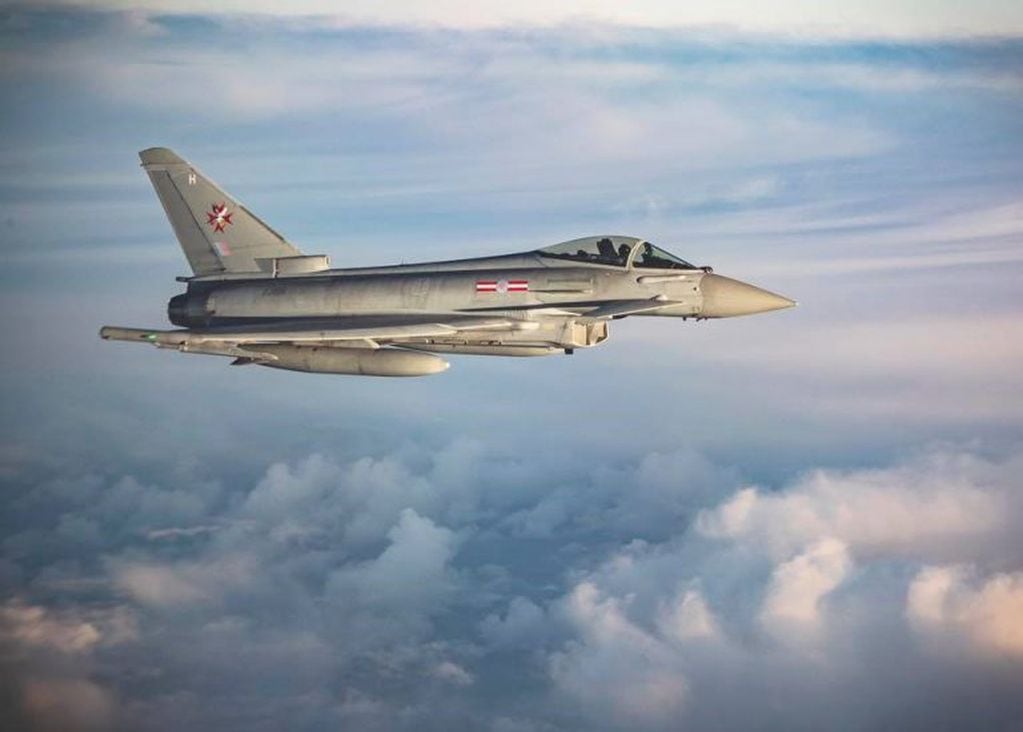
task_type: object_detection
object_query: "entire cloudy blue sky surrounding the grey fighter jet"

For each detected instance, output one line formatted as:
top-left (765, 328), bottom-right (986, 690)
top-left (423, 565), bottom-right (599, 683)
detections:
top-left (0, 0), bottom-right (1023, 732)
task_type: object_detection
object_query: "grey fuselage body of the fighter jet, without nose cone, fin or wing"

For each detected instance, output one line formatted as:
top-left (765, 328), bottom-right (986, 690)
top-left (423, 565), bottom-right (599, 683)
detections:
top-left (169, 251), bottom-right (716, 355)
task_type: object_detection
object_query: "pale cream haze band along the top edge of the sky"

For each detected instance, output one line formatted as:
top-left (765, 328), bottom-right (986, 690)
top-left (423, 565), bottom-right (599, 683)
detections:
top-left (49, 0), bottom-right (1023, 38)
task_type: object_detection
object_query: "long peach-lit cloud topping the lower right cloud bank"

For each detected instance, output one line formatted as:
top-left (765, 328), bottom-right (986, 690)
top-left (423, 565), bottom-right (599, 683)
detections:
top-left (697, 451), bottom-right (1023, 559)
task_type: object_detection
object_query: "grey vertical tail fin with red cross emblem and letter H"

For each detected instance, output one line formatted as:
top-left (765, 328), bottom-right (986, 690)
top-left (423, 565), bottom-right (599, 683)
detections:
top-left (138, 147), bottom-right (302, 275)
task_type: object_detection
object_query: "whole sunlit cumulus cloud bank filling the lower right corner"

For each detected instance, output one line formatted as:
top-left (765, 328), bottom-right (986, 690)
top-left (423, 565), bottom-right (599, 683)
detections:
top-left (531, 451), bottom-right (1023, 729)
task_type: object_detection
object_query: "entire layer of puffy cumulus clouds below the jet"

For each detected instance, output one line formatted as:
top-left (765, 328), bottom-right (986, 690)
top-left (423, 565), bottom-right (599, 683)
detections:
top-left (0, 440), bottom-right (1023, 730)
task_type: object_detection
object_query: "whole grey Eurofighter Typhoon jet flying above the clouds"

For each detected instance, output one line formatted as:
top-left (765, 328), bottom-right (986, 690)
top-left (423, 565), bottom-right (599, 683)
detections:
top-left (99, 147), bottom-right (795, 376)
